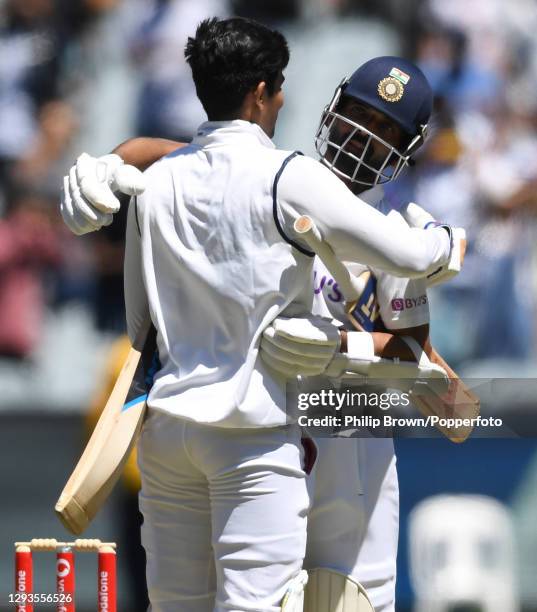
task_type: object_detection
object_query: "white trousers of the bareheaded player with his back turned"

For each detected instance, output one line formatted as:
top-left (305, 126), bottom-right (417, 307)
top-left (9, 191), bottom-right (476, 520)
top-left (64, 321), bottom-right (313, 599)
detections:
top-left (138, 410), bottom-right (309, 612)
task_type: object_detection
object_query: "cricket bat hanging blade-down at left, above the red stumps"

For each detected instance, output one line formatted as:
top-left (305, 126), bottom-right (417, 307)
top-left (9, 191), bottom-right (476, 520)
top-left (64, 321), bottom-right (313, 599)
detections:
top-left (55, 314), bottom-right (156, 535)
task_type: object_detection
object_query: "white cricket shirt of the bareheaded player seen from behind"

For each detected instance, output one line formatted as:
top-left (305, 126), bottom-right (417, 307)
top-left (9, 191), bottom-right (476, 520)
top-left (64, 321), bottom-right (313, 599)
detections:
top-left (125, 120), bottom-right (449, 427)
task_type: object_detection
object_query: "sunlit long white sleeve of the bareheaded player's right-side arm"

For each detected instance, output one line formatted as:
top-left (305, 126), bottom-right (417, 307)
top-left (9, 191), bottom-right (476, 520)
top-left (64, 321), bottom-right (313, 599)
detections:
top-left (277, 156), bottom-right (450, 278)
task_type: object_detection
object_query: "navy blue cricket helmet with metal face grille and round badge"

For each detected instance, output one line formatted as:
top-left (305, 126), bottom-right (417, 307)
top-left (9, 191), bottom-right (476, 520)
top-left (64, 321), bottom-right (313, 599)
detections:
top-left (315, 56), bottom-right (433, 189)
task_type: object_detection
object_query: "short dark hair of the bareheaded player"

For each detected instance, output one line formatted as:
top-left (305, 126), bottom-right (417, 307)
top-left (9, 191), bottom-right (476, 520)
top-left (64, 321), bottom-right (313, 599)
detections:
top-left (185, 17), bottom-right (289, 121)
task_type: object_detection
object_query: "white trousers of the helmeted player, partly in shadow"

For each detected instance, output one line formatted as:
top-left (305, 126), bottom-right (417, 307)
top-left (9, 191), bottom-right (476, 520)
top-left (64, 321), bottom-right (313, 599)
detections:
top-left (304, 438), bottom-right (399, 612)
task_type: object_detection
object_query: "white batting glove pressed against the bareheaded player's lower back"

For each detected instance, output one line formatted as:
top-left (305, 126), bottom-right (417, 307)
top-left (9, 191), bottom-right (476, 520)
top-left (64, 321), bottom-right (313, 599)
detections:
top-left (259, 316), bottom-right (340, 378)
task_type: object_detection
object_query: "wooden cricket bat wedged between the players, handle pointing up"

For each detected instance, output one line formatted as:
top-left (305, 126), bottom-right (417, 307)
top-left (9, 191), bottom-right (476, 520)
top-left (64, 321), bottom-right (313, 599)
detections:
top-left (294, 215), bottom-right (480, 443)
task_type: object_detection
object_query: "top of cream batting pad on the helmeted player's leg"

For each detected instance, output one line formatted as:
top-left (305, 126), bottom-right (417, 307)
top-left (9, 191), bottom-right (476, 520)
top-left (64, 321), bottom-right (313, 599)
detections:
top-left (304, 568), bottom-right (375, 612)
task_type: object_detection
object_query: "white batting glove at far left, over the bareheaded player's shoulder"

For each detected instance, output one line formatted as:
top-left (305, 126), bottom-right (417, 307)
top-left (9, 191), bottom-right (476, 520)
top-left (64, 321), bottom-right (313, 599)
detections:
top-left (60, 153), bottom-right (145, 236)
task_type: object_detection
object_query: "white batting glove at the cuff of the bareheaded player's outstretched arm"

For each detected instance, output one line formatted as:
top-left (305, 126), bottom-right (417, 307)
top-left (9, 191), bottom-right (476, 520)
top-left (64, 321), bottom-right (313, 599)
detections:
top-left (401, 202), bottom-right (466, 287)
